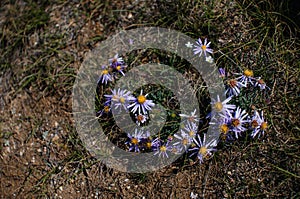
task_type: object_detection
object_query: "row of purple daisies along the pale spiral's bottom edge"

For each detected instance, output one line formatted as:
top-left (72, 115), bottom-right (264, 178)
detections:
top-left (126, 110), bottom-right (218, 163)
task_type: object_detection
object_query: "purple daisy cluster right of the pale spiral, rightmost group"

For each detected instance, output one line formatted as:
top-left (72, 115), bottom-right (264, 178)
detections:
top-left (212, 64), bottom-right (270, 141)
